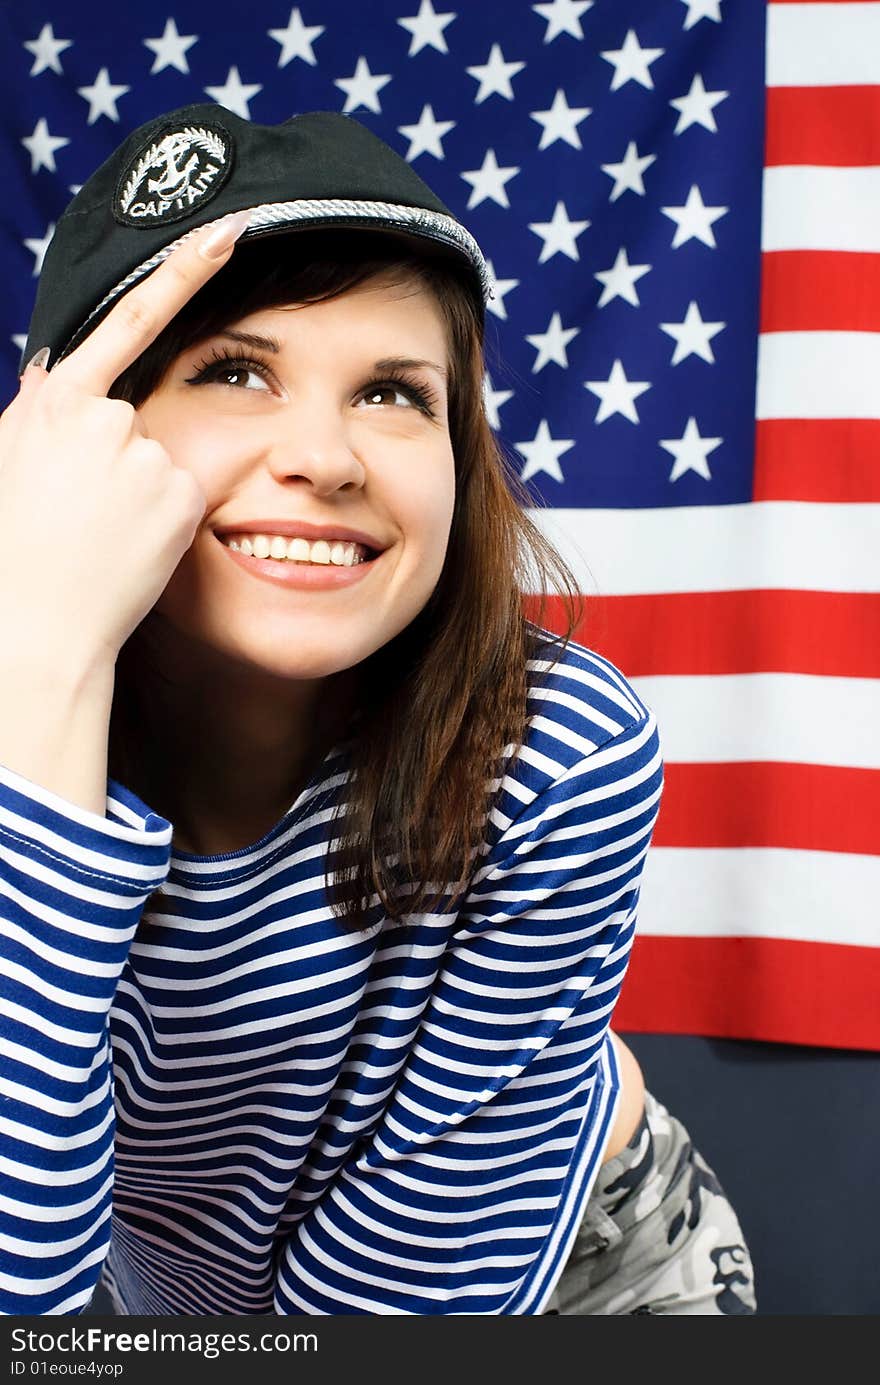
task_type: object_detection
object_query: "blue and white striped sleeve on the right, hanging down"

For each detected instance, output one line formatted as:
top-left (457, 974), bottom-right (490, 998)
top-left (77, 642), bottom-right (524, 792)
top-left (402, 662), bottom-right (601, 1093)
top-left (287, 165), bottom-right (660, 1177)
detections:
top-left (276, 709), bottom-right (662, 1314)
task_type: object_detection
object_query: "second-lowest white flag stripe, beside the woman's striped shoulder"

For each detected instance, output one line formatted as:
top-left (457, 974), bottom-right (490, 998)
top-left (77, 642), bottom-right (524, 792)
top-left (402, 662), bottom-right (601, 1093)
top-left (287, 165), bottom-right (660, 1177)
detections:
top-left (631, 673), bottom-right (880, 769)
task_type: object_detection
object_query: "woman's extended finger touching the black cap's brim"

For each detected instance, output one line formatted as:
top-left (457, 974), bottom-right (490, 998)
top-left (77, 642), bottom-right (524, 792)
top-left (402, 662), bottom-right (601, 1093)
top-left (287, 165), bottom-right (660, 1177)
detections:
top-left (53, 212), bottom-right (249, 395)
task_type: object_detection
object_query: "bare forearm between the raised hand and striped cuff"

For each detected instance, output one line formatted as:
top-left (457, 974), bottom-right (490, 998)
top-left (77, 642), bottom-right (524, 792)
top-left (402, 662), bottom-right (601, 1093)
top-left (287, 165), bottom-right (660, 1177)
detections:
top-left (0, 642), bottom-right (115, 817)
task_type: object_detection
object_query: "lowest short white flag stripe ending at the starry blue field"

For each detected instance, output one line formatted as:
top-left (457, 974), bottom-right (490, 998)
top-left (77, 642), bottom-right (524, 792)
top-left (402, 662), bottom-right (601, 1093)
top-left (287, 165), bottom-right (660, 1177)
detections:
top-left (755, 332), bottom-right (880, 418)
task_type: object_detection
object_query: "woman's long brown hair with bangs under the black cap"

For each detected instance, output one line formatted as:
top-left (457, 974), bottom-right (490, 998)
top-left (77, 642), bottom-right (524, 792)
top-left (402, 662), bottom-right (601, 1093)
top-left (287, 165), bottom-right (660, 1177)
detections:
top-left (109, 231), bottom-right (583, 927)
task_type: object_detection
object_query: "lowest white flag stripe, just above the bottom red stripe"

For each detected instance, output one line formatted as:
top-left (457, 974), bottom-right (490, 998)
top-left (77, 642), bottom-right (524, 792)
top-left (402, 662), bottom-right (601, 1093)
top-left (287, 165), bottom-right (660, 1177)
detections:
top-left (636, 846), bottom-right (880, 947)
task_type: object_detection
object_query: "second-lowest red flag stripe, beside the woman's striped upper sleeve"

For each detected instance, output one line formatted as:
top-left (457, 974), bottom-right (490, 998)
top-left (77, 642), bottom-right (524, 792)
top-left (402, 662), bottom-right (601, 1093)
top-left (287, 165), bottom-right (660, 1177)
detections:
top-left (653, 760), bottom-right (880, 853)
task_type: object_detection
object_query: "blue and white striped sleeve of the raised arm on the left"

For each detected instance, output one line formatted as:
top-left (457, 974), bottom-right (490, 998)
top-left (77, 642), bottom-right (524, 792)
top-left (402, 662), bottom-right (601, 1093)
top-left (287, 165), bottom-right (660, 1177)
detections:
top-left (0, 767), bottom-right (172, 1316)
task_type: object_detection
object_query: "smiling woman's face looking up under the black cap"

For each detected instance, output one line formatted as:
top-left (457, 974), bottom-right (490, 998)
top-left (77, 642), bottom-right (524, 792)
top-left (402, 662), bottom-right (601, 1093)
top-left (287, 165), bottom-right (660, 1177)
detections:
top-left (139, 274), bottom-right (455, 679)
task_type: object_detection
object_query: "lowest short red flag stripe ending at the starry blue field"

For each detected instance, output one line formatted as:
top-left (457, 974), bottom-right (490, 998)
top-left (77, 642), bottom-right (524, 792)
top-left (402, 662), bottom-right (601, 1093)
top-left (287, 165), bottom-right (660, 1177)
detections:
top-left (753, 418), bottom-right (880, 504)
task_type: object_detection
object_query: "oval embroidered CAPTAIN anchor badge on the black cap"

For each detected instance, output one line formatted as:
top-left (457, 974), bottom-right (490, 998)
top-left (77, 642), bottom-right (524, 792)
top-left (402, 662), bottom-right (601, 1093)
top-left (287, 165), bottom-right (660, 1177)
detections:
top-left (114, 125), bottom-right (233, 226)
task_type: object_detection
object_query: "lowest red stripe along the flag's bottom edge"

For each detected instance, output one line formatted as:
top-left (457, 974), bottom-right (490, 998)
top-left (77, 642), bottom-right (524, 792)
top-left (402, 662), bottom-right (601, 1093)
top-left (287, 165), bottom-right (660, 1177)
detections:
top-left (614, 933), bottom-right (880, 1050)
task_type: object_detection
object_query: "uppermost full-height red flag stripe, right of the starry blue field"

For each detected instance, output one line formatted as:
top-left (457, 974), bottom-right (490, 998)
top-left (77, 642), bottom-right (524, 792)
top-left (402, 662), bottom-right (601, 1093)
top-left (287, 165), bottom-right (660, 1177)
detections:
top-left (764, 86), bottom-right (880, 168)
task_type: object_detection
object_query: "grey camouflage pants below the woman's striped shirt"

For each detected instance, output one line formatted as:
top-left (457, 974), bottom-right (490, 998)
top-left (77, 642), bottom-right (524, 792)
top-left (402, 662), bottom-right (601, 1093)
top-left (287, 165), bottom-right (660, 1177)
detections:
top-left (545, 1093), bottom-right (755, 1316)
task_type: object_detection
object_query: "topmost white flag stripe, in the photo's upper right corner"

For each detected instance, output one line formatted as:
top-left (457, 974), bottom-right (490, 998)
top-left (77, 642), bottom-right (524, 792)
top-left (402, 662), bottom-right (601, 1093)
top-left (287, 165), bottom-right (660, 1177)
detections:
top-left (766, 4), bottom-right (880, 86)
